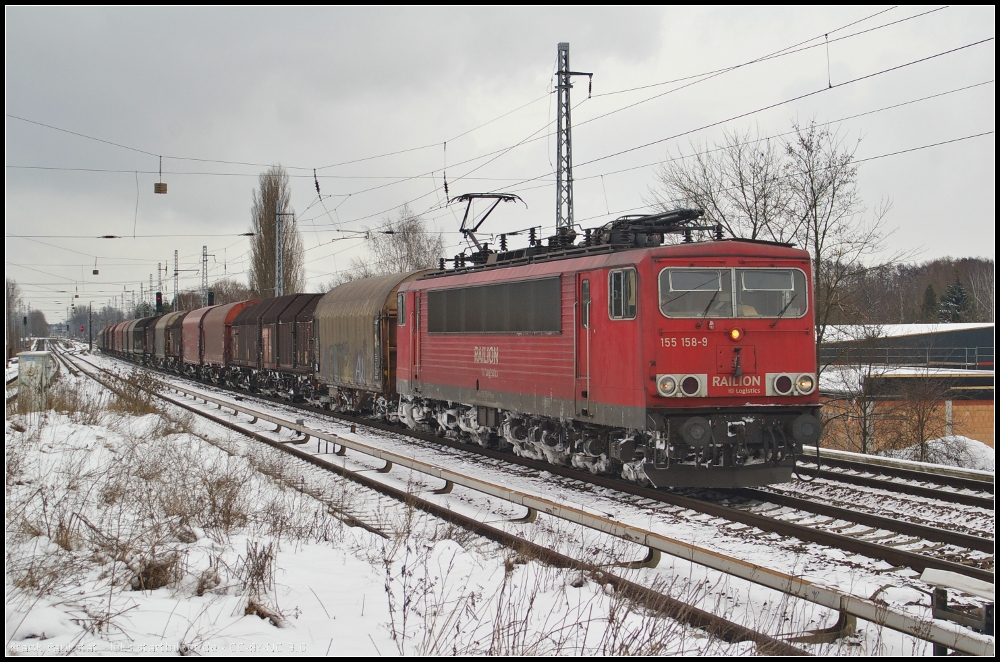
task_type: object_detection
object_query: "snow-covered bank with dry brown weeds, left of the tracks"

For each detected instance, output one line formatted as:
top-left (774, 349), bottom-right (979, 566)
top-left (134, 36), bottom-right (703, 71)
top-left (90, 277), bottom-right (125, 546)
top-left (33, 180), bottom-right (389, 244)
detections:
top-left (5, 376), bottom-right (755, 656)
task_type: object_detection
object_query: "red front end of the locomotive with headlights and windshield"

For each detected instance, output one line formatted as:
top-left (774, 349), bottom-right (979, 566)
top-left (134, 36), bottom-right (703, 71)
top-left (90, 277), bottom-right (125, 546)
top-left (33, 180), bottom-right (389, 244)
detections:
top-left (611, 241), bottom-right (821, 487)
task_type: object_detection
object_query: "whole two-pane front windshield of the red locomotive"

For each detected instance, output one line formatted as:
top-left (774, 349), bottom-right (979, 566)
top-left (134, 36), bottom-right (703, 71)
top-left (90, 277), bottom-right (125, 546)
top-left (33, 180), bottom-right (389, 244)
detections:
top-left (660, 269), bottom-right (808, 318)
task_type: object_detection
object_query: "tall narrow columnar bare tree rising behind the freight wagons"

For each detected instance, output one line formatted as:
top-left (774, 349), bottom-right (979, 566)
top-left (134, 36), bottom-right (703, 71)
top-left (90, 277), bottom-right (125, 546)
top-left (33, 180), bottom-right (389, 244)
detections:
top-left (250, 165), bottom-right (305, 299)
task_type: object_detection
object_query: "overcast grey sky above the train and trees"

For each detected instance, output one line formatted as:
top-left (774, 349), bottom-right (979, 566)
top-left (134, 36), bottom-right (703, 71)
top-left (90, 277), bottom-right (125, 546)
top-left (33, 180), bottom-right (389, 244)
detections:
top-left (4, 5), bottom-right (995, 321)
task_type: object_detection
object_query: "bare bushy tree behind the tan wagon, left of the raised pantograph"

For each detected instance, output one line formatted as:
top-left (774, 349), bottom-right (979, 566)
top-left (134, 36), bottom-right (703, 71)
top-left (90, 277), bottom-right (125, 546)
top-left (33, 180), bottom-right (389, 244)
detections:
top-left (323, 205), bottom-right (444, 291)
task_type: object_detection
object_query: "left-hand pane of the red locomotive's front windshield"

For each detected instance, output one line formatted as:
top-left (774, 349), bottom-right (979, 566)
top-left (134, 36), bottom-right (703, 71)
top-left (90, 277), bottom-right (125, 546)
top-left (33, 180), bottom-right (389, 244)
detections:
top-left (660, 269), bottom-right (733, 318)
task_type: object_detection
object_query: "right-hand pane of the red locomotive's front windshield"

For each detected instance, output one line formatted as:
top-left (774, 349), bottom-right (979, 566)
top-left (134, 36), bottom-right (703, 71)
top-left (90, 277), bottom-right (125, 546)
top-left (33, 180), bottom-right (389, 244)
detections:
top-left (736, 269), bottom-right (809, 317)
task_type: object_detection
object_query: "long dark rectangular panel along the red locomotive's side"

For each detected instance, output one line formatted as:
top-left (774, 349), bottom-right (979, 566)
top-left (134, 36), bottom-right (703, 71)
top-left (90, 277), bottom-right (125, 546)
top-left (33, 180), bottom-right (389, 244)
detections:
top-left (427, 277), bottom-right (562, 333)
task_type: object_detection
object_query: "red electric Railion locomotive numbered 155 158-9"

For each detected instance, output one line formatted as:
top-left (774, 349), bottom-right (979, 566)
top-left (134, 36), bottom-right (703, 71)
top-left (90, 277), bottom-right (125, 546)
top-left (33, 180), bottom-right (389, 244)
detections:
top-left (396, 210), bottom-right (820, 487)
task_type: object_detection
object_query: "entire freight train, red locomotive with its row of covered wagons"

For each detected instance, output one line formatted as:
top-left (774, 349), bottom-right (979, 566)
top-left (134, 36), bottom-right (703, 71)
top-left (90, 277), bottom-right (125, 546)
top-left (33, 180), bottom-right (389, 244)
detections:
top-left (100, 210), bottom-right (820, 488)
